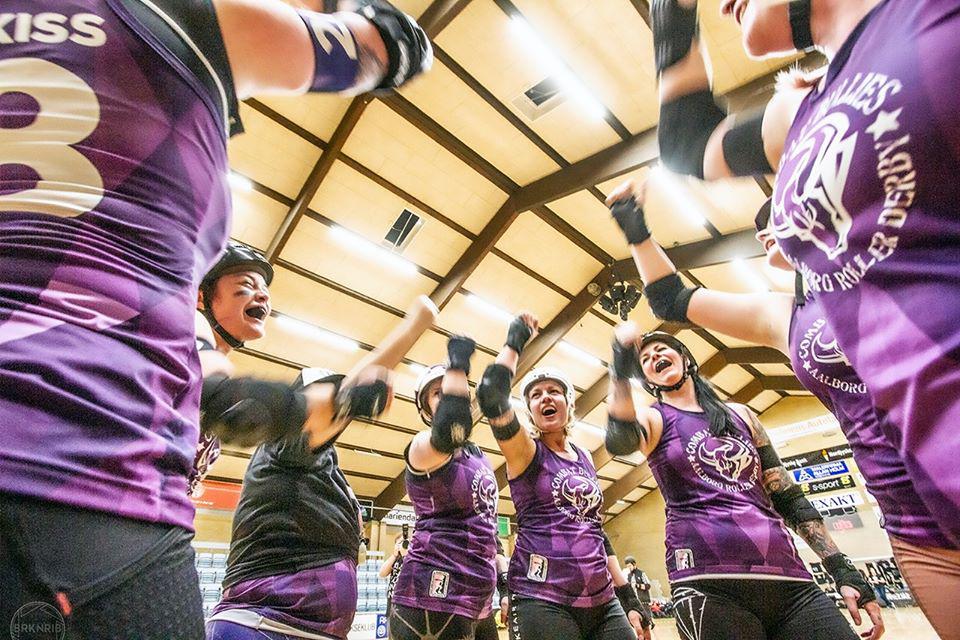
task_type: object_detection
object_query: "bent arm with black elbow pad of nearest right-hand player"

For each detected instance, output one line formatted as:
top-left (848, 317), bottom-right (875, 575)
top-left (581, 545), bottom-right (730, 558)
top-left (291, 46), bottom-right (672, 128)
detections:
top-left (650, 0), bottom-right (807, 180)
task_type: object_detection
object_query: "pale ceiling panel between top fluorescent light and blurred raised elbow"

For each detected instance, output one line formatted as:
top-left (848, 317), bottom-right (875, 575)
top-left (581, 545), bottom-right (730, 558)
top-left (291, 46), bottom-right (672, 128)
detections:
top-left (515, 0), bottom-right (658, 133)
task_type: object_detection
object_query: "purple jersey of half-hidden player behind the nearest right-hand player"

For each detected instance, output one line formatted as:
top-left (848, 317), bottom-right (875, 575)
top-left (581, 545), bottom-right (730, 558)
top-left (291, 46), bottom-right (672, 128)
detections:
top-left (790, 297), bottom-right (956, 548)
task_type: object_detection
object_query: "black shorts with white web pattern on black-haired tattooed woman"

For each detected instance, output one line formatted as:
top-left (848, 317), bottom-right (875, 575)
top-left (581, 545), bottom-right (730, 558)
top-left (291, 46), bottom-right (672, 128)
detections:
top-left (672, 578), bottom-right (858, 640)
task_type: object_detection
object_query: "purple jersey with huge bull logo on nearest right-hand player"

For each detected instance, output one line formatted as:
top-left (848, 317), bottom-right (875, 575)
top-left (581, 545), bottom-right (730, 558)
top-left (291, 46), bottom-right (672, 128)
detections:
top-left (771, 0), bottom-right (960, 541)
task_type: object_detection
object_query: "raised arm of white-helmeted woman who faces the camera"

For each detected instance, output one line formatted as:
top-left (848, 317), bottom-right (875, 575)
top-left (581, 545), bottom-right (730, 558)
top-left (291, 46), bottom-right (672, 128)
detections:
top-left (477, 313), bottom-right (539, 478)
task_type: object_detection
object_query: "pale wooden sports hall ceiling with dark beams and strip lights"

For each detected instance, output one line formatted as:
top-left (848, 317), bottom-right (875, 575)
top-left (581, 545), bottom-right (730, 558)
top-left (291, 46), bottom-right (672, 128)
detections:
top-left (211, 0), bottom-right (803, 516)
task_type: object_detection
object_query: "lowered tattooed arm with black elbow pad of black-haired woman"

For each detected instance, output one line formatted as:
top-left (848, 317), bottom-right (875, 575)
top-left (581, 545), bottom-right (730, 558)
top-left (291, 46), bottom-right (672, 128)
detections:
top-left (731, 405), bottom-right (883, 640)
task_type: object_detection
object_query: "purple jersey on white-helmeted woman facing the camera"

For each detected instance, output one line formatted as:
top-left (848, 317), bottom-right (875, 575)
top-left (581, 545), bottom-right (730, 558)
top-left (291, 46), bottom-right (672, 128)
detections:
top-left (508, 440), bottom-right (614, 607)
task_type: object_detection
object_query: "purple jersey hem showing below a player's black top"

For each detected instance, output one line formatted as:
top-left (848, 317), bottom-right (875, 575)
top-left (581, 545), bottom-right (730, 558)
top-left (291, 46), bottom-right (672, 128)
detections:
top-left (213, 558), bottom-right (357, 638)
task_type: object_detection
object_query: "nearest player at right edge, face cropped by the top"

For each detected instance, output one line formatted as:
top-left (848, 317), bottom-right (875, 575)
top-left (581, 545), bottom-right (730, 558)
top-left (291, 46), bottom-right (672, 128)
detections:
top-left (651, 0), bottom-right (960, 580)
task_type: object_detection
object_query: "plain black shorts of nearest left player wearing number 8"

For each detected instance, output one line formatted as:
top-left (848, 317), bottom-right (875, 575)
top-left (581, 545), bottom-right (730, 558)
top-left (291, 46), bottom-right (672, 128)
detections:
top-left (0, 494), bottom-right (204, 640)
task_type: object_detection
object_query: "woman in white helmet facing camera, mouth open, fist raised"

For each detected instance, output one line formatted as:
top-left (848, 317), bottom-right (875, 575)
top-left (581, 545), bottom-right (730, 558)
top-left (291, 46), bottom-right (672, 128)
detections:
top-left (477, 320), bottom-right (642, 640)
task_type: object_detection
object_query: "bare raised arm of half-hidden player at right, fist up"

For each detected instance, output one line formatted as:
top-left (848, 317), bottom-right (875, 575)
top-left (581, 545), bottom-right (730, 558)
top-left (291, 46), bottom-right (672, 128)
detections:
top-left (607, 181), bottom-right (793, 353)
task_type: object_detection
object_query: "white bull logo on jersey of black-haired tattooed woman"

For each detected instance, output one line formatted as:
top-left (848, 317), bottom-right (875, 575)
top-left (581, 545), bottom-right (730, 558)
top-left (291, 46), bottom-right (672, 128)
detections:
top-left (686, 429), bottom-right (760, 493)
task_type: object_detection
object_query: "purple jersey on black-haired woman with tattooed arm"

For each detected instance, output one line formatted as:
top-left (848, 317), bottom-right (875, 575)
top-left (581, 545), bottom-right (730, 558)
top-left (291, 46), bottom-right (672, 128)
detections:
top-left (648, 403), bottom-right (812, 583)
